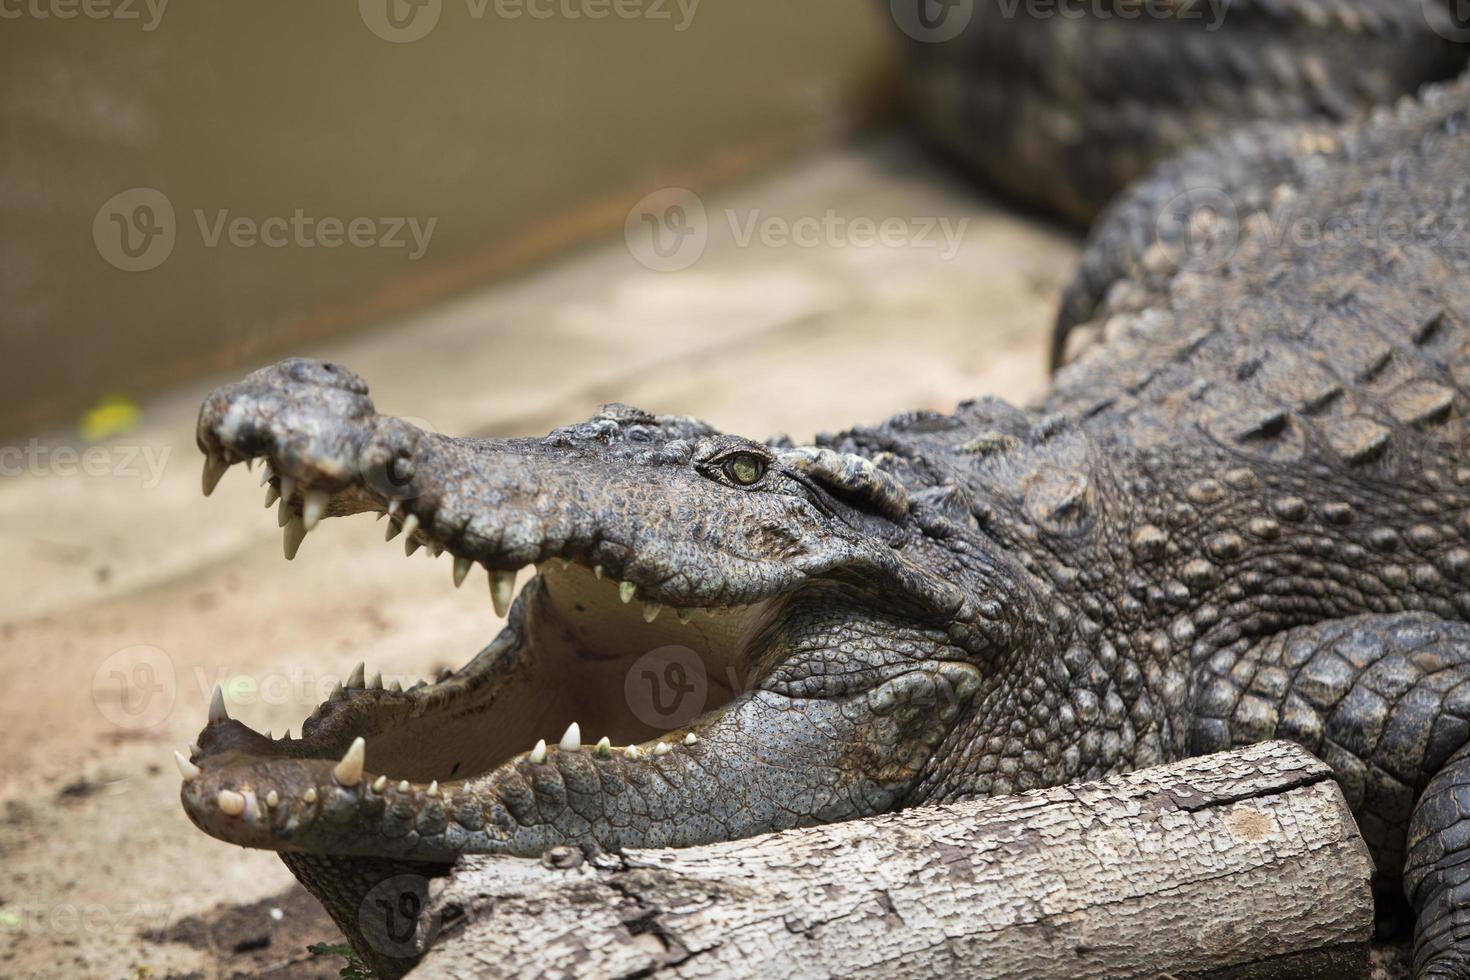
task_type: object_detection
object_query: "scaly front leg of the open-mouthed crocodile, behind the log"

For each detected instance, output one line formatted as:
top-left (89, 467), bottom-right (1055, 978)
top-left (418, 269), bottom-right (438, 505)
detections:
top-left (1191, 613), bottom-right (1470, 977)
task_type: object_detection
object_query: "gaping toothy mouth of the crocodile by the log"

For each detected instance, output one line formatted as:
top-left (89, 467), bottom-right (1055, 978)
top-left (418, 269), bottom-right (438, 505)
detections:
top-left (178, 455), bottom-right (772, 860)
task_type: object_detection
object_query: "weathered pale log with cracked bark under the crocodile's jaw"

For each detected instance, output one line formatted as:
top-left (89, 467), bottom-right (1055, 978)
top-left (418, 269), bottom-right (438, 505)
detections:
top-left (415, 742), bottom-right (1373, 979)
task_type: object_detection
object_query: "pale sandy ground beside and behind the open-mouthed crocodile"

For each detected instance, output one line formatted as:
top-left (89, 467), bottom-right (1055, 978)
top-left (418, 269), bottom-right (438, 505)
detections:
top-left (0, 143), bottom-right (1076, 977)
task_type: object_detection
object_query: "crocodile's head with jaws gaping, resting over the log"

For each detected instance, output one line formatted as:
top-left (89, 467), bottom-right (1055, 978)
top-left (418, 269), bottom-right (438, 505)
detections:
top-left (181, 360), bottom-right (1017, 963)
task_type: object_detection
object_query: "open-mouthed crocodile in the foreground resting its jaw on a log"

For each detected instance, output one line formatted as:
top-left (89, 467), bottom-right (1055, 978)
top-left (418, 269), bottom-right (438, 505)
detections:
top-left (186, 3), bottom-right (1470, 977)
